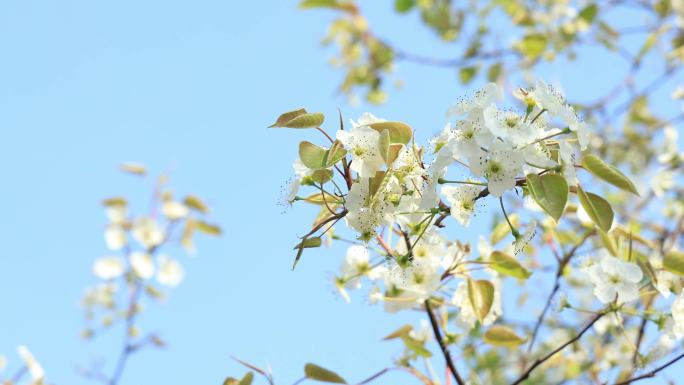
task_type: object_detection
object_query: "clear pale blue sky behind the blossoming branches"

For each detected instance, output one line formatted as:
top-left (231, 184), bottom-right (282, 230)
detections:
top-left (0, 0), bottom-right (681, 384)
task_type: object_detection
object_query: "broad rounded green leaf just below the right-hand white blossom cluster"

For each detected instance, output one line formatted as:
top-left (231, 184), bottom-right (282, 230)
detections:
top-left (527, 174), bottom-right (568, 222)
